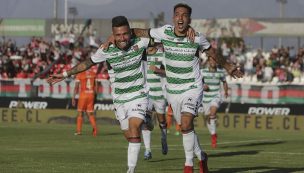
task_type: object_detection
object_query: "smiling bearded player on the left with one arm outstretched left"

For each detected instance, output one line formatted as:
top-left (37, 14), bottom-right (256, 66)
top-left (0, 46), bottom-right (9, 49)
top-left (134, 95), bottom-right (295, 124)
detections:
top-left (47, 16), bottom-right (154, 173)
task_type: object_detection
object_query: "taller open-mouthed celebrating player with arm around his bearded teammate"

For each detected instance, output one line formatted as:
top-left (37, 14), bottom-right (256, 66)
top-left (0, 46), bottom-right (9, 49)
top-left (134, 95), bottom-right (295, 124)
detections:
top-left (132, 3), bottom-right (243, 173)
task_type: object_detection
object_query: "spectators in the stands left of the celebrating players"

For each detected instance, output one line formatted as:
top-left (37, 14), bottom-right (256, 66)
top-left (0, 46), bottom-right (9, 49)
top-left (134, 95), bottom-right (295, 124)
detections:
top-left (0, 32), bottom-right (108, 79)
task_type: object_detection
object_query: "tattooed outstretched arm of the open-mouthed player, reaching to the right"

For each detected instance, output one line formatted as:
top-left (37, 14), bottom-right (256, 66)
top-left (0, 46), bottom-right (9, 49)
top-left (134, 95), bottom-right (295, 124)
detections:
top-left (206, 48), bottom-right (244, 78)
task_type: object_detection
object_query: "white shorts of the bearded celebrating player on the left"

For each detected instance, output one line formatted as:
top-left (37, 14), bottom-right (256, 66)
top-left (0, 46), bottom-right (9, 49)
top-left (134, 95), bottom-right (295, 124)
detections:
top-left (114, 97), bottom-right (148, 130)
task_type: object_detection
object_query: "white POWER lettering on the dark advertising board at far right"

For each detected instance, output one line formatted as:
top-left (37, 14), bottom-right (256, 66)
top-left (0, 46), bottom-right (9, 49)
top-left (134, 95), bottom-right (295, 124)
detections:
top-left (248, 107), bottom-right (290, 115)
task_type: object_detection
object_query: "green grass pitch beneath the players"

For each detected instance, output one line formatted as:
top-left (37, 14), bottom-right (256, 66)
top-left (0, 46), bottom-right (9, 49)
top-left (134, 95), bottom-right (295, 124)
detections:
top-left (0, 123), bottom-right (304, 173)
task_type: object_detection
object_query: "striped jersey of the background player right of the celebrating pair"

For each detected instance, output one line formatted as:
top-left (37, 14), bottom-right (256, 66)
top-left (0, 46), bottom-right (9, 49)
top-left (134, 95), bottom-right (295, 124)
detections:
top-left (201, 68), bottom-right (226, 103)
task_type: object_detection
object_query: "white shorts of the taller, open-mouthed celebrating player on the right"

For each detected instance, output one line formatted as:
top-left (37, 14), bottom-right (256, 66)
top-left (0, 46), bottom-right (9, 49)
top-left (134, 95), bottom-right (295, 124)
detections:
top-left (167, 88), bottom-right (203, 125)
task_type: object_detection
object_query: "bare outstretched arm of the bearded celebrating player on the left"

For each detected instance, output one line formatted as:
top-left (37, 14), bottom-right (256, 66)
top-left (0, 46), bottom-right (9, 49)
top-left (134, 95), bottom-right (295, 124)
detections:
top-left (47, 58), bottom-right (94, 85)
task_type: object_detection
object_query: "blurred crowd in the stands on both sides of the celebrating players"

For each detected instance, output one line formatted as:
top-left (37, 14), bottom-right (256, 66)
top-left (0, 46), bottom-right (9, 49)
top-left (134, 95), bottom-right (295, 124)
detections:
top-left (0, 32), bottom-right (304, 83)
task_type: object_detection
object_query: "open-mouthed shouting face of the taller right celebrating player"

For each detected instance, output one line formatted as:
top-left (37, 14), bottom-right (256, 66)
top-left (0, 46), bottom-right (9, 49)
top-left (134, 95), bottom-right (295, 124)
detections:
top-left (173, 7), bottom-right (191, 36)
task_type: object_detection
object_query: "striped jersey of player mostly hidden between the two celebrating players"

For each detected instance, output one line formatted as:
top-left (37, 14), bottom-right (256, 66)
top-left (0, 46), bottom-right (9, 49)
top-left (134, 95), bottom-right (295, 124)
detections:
top-left (147, 49), bottom-right (165, 100)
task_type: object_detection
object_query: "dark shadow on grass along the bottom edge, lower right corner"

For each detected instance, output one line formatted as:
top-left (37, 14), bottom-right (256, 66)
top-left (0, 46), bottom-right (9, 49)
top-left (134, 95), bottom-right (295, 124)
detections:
top-left (209, 166), bottom-right (304, 173)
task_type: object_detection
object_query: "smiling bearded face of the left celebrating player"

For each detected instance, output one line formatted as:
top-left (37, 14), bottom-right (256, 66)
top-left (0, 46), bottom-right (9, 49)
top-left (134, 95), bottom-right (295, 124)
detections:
top-left (112, 25), bottom-right (131, 50)
